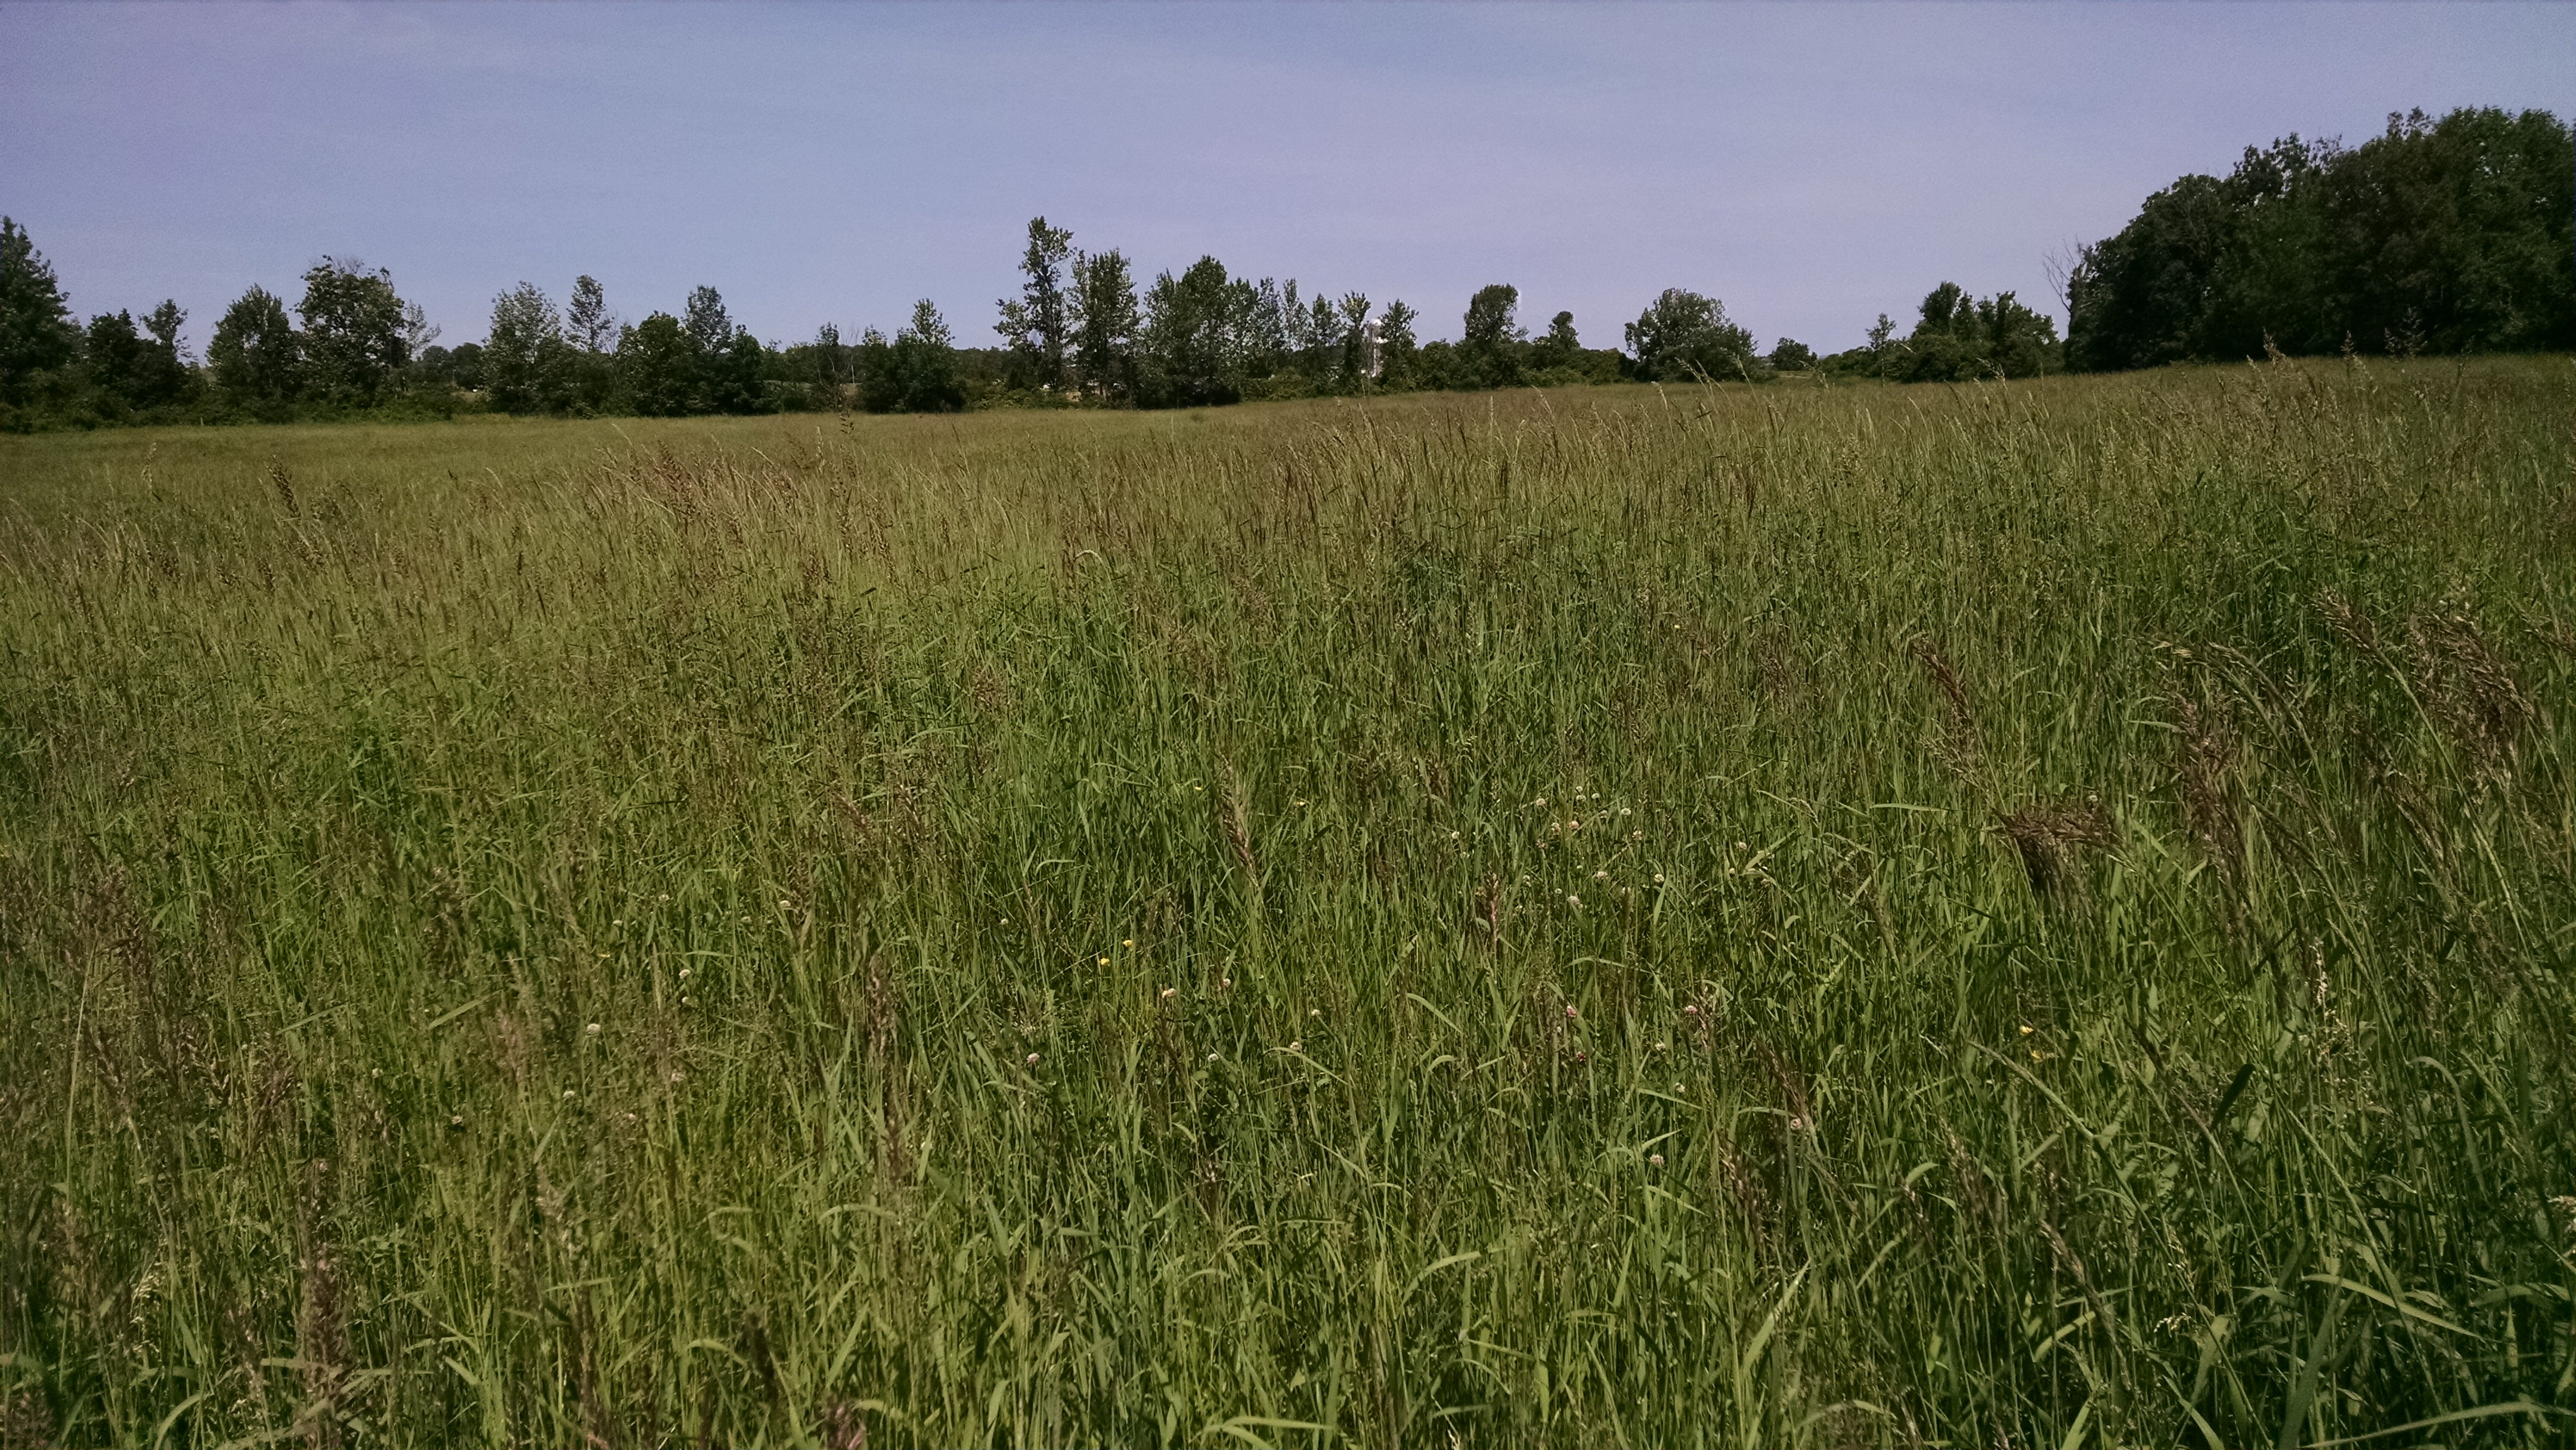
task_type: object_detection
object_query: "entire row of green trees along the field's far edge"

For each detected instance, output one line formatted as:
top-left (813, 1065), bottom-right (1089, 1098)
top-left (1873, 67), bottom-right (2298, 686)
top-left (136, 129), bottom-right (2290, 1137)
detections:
top-left (0, 111), bottom-right (2576, 430)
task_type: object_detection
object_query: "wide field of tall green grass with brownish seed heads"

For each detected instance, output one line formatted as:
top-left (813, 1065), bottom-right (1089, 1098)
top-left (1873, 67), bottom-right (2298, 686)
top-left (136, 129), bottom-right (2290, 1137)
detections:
top-left (0, 358), bottom-right (2576, 1450)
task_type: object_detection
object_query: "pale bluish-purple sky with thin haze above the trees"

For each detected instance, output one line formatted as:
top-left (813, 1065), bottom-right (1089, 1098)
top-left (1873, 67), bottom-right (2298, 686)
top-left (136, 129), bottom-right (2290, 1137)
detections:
top-left (0, 2), bottom-right (2576, 350)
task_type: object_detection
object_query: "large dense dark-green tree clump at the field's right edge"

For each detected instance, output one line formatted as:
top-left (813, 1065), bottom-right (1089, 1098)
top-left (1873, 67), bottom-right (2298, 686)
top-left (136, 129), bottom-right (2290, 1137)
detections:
top-left (2069, 108), bottom-right (2576, 371)
